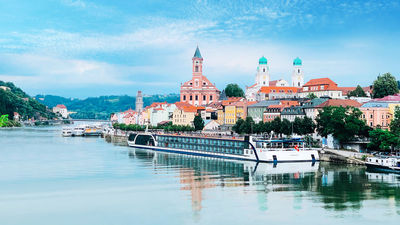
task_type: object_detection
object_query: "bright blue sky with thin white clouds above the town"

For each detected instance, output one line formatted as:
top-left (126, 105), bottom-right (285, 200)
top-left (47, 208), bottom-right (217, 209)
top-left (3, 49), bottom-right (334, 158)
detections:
top-left (0, 0), bottom-right (400, 98)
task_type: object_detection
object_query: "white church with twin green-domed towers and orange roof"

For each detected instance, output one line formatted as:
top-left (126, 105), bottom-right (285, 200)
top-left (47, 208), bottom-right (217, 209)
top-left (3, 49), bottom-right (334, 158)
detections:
top-left (246, 56), bottom-right (304, 101)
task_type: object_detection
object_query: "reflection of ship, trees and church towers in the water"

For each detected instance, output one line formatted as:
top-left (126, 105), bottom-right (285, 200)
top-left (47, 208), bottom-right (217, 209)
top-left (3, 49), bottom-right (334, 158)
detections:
top-left (129, 150), bottom-right (400, 214)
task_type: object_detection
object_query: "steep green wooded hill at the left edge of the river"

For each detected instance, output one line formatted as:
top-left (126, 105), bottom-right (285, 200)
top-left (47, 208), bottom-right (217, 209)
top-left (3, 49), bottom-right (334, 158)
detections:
top-left (0, 81), bottom-right (55, 119)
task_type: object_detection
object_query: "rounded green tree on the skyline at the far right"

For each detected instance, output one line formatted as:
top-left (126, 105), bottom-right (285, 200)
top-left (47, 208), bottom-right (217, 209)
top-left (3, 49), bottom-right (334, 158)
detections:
top-left (372, 73), bottom-right (399, 98)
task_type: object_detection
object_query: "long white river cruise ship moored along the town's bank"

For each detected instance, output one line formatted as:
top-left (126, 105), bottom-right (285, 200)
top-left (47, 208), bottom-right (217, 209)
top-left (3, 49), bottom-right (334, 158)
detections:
top-left (128, 132), bottom-right (319, 163)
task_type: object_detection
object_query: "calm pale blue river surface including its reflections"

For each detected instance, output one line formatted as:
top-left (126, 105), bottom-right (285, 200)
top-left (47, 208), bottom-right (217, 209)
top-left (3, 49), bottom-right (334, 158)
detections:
top-left (0, 125), bottom-right (400, 225)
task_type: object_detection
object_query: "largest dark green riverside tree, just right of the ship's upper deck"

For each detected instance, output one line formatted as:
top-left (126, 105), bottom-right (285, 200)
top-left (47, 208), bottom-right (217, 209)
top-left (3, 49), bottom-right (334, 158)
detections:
top-left (316, 106), bottom-right (366, 146)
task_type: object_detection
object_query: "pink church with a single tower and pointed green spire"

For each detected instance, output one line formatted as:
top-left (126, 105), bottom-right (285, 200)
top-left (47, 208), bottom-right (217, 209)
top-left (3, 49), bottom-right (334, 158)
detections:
top-left (181, 47), bottom-right (220, 106)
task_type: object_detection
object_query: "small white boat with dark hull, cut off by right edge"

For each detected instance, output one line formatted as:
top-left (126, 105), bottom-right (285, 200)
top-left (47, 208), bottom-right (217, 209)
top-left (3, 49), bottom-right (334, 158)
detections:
top-left (365, 156), bottom-right (400, 173)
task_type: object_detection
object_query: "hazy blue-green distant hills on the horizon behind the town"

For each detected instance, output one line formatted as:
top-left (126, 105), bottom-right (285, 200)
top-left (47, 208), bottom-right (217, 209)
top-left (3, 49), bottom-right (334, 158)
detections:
top-left (35, 94), bottom-right (179, 119)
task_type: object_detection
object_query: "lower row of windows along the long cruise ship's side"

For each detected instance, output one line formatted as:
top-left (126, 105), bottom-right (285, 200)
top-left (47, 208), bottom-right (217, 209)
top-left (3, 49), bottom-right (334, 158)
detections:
top-left (158, 142), bottom-right (243, 155)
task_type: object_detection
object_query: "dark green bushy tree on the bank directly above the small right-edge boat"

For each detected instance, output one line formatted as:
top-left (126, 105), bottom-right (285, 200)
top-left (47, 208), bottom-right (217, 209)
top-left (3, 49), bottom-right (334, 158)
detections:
top-left (367, 129), bottom-right (399, 151)
